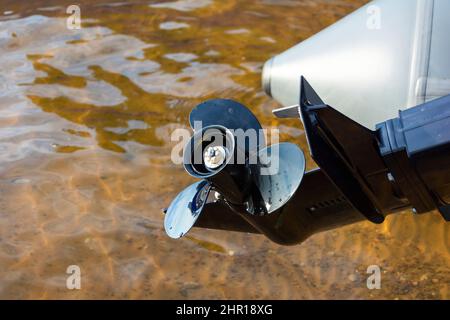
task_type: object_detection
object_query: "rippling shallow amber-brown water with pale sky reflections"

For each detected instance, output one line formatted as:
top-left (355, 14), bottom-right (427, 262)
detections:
top-left (0, 0), bottom-right (450, 299)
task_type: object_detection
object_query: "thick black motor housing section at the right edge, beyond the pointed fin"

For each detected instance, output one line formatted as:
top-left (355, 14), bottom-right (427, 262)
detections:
top-left (377, 96), bottom-right (450, 221)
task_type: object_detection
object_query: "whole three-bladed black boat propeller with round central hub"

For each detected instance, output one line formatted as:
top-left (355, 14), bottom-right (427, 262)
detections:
top-left (164, 99), bottom-right (305, 238)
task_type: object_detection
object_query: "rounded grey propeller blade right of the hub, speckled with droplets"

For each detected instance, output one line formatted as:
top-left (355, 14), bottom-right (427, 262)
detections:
top-left (254, 143), bottom-right (306, 214)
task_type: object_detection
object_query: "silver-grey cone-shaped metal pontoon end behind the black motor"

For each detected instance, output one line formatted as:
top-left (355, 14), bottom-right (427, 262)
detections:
top-left (263, 0), bottom-right (450, 129)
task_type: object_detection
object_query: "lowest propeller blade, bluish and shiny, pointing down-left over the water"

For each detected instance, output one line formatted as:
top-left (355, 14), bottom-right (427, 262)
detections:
top-left (164, 180), bottom-right (211, 239)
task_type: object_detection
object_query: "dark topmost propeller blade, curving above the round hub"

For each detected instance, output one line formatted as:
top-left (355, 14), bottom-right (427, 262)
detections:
top-left (189, 99), bottom-right (265, 151)
